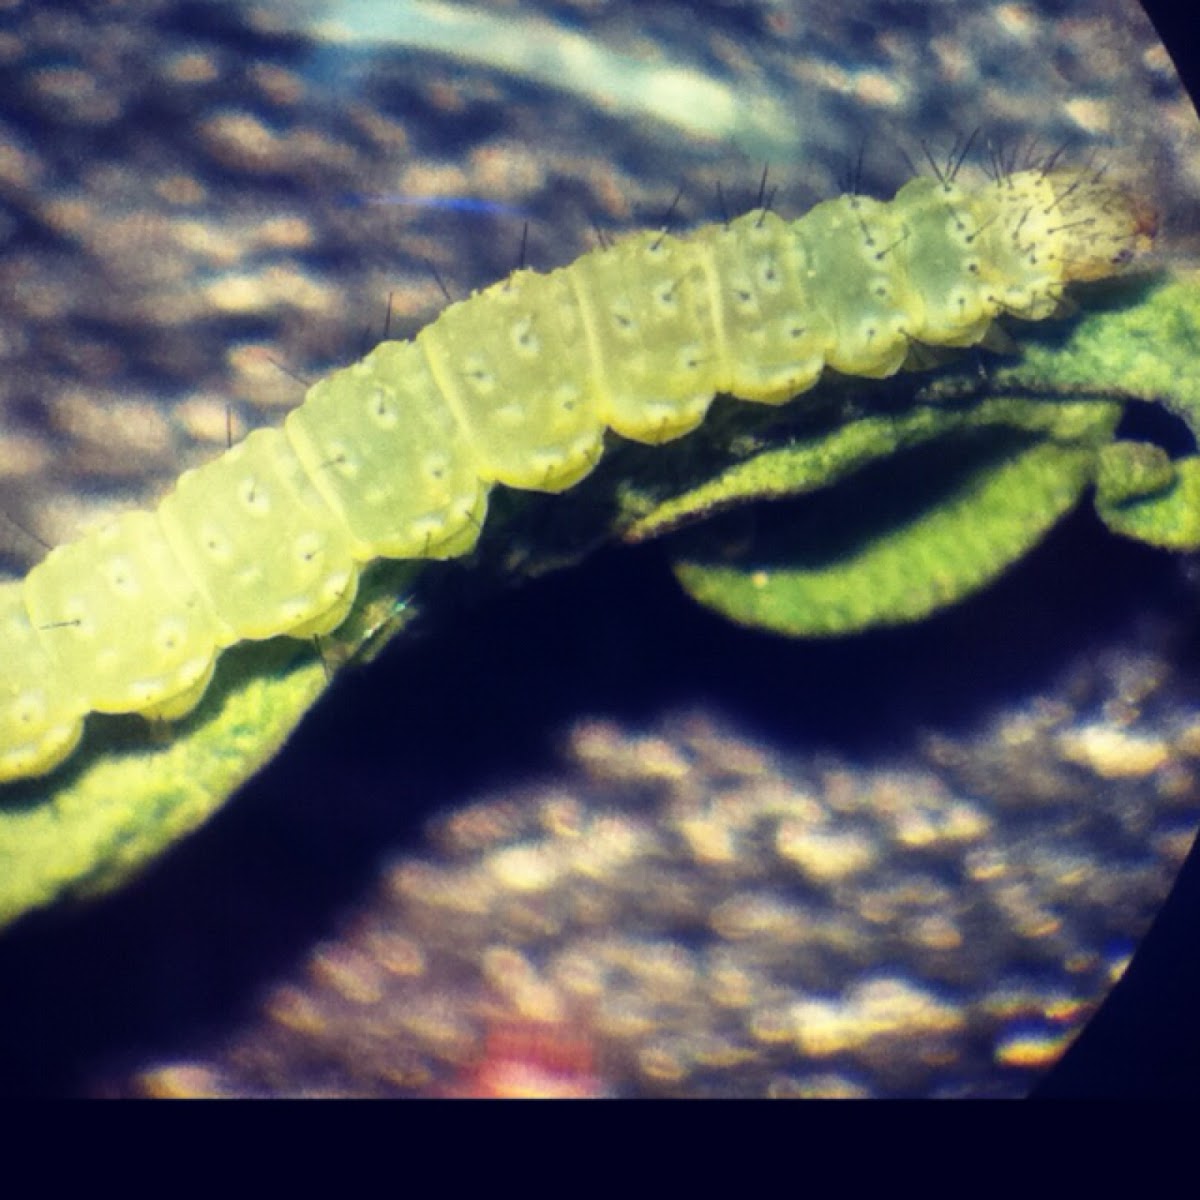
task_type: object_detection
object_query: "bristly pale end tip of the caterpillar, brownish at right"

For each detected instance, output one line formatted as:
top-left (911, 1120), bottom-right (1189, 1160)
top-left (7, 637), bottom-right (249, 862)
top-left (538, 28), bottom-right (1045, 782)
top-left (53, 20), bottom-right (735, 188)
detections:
top-left (1054, 175), bottom-right (1158, 283)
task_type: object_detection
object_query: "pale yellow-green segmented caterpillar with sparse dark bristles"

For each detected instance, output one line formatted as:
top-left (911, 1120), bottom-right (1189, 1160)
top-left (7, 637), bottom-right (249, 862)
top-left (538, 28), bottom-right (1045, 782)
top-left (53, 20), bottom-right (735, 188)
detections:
top-left (0, 163), bottom-right (1154, 782)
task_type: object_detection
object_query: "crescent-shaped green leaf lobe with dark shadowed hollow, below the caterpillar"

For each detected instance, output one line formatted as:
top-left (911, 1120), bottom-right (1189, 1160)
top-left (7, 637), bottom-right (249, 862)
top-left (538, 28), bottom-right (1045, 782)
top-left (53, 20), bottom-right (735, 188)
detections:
top-left (674, 427), bottom-right (1113, 637)
